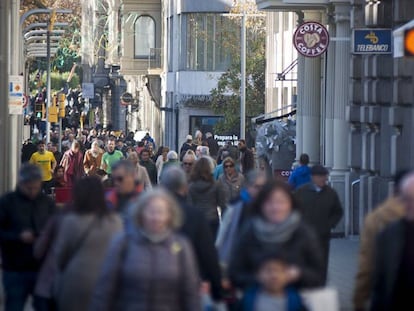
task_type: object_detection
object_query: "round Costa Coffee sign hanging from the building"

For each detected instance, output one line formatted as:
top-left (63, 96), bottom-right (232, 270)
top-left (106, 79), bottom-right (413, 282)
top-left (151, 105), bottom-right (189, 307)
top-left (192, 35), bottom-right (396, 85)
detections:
top-left (293, 22), bottom-right (329, 57)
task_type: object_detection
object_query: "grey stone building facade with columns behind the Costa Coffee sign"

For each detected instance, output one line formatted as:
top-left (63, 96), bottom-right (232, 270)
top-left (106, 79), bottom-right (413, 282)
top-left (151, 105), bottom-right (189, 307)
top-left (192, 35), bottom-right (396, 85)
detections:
top-left (256, 0), bottom-right (414, 235)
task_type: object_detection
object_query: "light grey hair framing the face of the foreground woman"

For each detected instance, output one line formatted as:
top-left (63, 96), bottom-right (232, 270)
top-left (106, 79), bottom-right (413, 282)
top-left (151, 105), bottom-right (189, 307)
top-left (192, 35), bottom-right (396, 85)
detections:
top-left (128, 188), bottom-right (182, 230)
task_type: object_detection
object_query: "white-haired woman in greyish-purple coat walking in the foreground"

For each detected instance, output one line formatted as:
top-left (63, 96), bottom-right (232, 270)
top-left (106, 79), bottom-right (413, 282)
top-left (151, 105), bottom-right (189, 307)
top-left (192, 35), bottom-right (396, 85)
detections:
top-left (90, 189), bottom-right (201, 311)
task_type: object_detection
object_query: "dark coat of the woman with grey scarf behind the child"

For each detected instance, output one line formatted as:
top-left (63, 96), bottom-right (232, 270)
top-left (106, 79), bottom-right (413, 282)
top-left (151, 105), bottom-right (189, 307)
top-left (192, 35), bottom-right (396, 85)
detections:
top-left (229, 219), bottom-right (323, 288)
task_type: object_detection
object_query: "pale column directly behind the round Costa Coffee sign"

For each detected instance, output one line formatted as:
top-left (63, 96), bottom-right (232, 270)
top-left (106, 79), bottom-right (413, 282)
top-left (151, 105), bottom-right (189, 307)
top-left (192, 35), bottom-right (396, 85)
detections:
top-left (298, 11), bottom-right (322, 163)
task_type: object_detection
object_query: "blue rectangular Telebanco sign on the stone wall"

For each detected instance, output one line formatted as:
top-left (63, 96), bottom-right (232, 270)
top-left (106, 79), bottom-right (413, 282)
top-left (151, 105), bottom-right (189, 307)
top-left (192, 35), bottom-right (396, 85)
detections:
top-left (352, 28), bottom-right (392, 54)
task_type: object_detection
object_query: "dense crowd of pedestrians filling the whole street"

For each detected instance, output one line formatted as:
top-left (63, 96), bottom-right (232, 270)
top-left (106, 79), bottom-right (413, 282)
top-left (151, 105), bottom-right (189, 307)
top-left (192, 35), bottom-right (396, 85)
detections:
top-left (0, 130), bottom-right (414, 311)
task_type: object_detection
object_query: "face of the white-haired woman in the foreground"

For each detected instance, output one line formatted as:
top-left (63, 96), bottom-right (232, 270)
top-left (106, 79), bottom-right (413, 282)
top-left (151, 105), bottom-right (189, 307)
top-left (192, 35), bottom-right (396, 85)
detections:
top-left (142, 198), bottom-right (171, 234)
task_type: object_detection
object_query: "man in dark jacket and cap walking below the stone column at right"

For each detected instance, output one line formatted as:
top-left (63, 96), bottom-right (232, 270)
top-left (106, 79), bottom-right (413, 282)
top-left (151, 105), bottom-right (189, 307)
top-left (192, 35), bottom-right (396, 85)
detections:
top-left (295, 165), bottom-right (343, 282)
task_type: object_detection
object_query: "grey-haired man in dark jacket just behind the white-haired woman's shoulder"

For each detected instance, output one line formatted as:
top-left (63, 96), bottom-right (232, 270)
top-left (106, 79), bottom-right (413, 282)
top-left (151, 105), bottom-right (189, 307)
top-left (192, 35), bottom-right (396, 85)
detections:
top-left (161, 166), bottom-right (223, 308)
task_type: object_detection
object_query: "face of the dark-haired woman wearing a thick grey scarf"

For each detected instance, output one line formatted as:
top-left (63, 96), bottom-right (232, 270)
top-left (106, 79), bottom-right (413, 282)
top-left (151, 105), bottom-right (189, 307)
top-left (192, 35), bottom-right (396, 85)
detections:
top-left (262, 190), bottom-right (292, 223)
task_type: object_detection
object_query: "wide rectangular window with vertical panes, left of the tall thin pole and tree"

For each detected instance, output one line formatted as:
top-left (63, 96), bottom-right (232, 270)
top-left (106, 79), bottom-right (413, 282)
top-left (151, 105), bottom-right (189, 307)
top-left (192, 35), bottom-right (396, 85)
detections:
top-left (183, 14), bottom-right (230, 71)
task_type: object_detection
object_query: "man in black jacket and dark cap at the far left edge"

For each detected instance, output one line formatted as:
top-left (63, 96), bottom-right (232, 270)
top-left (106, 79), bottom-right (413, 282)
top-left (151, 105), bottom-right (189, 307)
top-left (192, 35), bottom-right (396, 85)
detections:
top-left (0, 164), bottom-right (55, 311)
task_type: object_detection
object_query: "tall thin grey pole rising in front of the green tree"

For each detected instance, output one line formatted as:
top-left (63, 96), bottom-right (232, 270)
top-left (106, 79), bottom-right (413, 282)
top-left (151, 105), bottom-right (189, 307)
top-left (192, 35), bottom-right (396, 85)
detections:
top-left (240, 3), bottom-right (246, 139)
